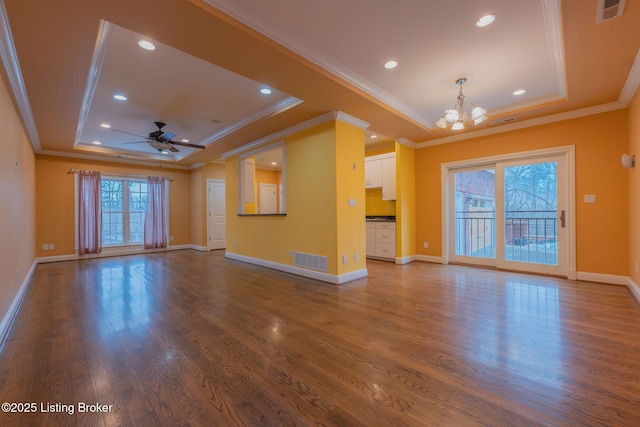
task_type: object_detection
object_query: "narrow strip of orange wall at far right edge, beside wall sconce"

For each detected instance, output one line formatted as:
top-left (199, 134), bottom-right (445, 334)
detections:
top-left (625, 92), bottom-right (640, 285)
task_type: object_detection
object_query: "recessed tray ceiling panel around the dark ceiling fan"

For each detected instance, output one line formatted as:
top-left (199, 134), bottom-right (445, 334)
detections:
top-left (75, 21), bottom-right (300, 160)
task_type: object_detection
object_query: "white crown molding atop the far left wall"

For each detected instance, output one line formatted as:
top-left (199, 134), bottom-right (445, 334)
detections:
top-left (0, 0), bottom-right (42, 151)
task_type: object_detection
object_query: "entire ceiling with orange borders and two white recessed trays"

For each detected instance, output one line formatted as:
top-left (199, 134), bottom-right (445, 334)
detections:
top-left (0, 0), bottom-right (640, 168)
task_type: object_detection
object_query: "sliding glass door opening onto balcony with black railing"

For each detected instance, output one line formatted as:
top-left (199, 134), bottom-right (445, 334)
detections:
top-left (448, 157), bottom-right (567, 275)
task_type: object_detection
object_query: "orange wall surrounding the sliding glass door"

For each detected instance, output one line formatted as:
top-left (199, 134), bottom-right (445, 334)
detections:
top-left (416, 110), bottom-right (637, 276)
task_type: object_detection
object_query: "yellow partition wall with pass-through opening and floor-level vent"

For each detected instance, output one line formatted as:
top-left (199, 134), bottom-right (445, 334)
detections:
top-left (226, 122), bottom-right (366, 275)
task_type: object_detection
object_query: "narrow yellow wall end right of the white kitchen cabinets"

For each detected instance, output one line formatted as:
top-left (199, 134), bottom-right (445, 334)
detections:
top-left (396, 142), bottom-right (416, 258)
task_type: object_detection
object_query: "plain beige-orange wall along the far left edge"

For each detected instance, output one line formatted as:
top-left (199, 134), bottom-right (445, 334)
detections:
top-left (0, 72), bottom-right (36, 326)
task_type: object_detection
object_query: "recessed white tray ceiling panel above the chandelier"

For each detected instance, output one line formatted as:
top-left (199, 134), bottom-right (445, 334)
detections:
top-left (207, 0), bottom-right (565, 128)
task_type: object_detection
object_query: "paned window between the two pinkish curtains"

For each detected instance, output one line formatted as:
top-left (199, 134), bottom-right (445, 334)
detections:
top-left (102, 178), bottom-right (147, 246)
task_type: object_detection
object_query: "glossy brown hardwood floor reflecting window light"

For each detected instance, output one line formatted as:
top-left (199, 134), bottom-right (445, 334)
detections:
top-left (0, 251), bottom-right (640, 426)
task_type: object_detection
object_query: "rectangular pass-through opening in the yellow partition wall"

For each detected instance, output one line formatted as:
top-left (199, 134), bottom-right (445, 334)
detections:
top-left (238, 142), bottom-right (286, 215)
